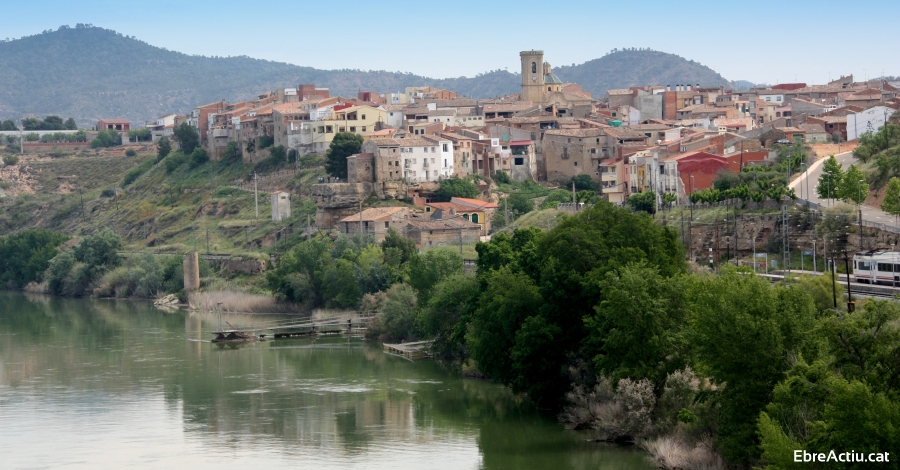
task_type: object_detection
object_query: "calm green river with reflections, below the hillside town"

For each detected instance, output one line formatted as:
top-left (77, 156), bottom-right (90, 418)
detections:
top-left (0, 292), bottom-right (654, 470)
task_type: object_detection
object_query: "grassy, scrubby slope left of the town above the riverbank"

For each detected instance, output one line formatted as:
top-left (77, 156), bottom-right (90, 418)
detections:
top-left (0, 154), bottom-right (324, 257)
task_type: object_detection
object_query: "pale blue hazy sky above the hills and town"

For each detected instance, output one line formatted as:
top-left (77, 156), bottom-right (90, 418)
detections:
top-left (0, 0), bottom-right (900, 83)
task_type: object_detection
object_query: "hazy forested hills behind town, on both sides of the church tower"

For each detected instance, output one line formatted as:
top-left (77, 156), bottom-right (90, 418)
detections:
top-left (0, 25), bottom-right (740, 126)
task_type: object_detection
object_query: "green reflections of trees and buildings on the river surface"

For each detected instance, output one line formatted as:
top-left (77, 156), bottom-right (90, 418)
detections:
top-left (0, 293), bottom-right (652, 468)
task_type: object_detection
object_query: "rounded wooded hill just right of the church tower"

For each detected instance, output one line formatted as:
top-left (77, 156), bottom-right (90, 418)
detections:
top-left (553, 49), bottom-right (733, 93)
